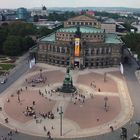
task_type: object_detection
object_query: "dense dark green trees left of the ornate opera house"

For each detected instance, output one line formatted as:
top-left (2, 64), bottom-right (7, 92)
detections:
top-left (0, 21), bottom-right (57, 56)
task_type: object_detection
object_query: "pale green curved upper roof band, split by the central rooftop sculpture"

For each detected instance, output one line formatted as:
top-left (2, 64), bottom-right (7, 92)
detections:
top-left (57, 26), bottom-right (104, 33)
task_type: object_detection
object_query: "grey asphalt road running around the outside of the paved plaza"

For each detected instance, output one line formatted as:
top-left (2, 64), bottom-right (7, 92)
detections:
top-left (0, 50), bottom-right (140, 140)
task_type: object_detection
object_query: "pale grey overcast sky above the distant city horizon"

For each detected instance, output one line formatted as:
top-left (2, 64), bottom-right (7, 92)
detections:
top-left (0, 0), bottom-right (140, 8)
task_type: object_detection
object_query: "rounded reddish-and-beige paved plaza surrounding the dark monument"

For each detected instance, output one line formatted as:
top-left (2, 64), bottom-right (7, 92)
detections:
top-left (0, 64), bottom-right (133, 138)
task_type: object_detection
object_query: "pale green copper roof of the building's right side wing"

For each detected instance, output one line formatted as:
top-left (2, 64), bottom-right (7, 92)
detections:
top-left (105, 34), bottom-right (122, 44)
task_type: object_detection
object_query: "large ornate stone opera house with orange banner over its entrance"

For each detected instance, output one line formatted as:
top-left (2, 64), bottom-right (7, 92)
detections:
top-left (30, 15), bottom-right (123, 69)
